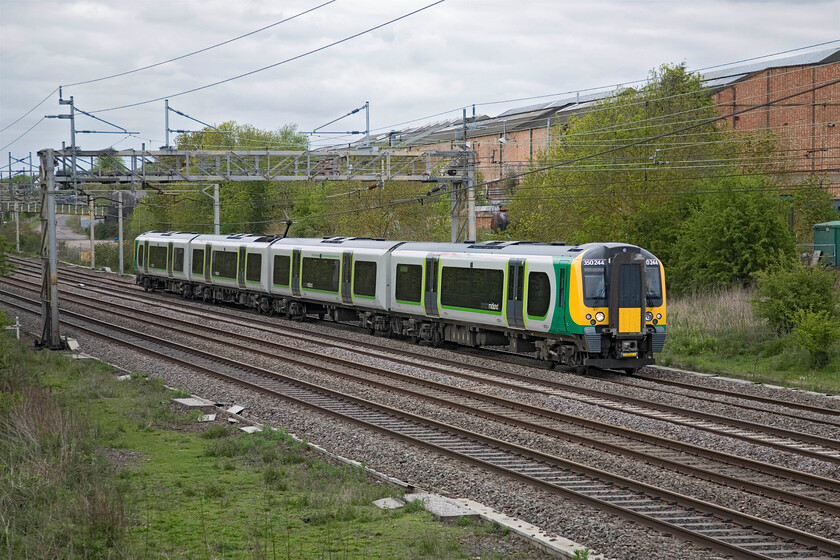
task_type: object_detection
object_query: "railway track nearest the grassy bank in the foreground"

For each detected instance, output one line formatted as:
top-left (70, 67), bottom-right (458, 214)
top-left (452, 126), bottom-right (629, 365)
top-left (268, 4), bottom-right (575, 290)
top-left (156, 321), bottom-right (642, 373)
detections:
top-left (1, 288), bottom-right (840, 560)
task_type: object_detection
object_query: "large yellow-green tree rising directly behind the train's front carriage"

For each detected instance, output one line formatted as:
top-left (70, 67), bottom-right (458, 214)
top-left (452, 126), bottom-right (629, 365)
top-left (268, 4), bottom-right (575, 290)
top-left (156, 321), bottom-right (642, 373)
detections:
top-left (506, 65), bottom-right (726, 260)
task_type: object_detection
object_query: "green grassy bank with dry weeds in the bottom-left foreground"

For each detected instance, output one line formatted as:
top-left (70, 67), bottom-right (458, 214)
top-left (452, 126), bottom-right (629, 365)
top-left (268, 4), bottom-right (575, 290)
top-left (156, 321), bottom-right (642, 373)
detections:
top-left (0, 320), bottom-right (540, 560)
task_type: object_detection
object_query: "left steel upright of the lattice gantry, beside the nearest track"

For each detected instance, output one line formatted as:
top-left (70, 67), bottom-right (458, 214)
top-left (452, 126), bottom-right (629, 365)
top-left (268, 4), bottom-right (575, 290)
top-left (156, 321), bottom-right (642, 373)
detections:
top-left (38, 149), bottom-right (64, 350)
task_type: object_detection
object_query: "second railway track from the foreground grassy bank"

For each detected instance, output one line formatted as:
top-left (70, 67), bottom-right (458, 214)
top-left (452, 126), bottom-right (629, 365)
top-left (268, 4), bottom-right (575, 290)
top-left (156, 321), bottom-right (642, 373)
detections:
top-left (0, 278), bottom-right (840, 516)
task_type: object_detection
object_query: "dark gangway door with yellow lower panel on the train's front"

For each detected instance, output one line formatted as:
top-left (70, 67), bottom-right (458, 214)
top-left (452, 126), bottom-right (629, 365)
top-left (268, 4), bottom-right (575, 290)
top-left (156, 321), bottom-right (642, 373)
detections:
top-left (610, 247), bottom-right (646, 334)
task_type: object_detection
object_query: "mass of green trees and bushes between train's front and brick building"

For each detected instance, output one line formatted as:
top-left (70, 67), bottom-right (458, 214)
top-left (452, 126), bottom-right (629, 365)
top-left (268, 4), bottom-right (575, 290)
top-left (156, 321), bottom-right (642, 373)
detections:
top-left (501, 61), bottom-right (831, 293)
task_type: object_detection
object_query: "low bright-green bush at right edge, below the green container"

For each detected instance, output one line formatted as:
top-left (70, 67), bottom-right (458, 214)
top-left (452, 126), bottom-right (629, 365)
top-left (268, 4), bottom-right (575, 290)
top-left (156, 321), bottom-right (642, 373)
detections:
top-left (753, 263), bottom-right (840, 333)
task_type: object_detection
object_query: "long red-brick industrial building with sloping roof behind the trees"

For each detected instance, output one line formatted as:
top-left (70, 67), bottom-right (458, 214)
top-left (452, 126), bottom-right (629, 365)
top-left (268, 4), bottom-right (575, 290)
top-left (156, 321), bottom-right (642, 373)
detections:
top-left (360, 48), bottom-right (840, 223)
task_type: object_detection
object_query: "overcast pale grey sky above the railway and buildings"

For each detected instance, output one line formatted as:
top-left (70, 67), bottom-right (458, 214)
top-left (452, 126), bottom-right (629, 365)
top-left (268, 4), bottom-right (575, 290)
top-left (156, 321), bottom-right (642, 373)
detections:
top-left (0, 0), bottom-right (840, 174)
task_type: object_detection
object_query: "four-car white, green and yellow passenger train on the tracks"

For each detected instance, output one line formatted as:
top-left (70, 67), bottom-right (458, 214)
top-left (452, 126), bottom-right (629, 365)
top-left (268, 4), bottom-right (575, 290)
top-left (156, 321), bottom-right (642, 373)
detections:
top-left (134, 231), bottom-right (666, 372)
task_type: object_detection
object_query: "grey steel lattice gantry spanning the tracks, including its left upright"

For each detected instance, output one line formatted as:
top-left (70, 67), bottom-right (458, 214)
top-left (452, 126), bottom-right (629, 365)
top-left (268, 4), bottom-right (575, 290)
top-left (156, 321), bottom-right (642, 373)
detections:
top-left (38, 148), bottom-right (475, 349)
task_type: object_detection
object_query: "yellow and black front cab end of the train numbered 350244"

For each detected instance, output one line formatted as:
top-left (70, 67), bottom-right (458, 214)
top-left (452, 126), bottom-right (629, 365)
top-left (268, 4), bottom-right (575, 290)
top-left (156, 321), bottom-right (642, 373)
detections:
top-left (570, 245), bottom-right (665, 371)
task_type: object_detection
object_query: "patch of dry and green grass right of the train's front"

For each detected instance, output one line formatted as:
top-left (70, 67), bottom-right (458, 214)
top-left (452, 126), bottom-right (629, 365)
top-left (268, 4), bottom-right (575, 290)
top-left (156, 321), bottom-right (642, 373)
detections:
top-left (658, 288), bottom-right (840, 393)
